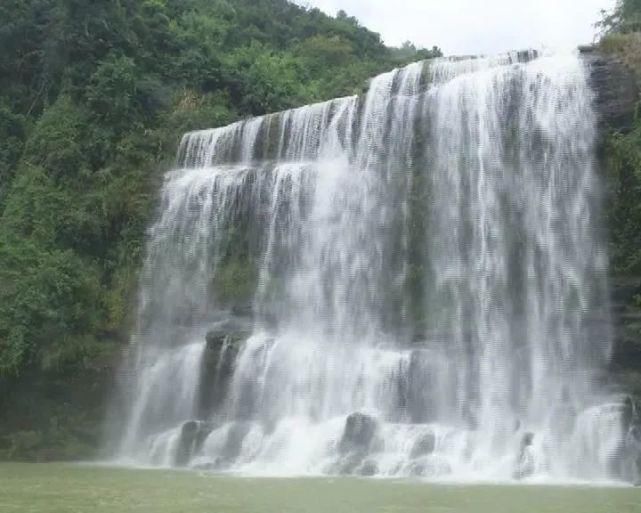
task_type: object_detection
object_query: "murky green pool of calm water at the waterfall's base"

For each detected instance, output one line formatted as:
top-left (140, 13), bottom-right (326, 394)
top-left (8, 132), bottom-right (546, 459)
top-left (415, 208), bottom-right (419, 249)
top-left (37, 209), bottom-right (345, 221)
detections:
top-left (0, 463), bottom-right (641, 513)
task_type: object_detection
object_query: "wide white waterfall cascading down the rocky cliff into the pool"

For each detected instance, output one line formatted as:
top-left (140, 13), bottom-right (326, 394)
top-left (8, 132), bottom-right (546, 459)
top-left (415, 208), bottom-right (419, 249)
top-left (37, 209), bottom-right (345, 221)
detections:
top-left (111, 53), bottom-right (631, 479)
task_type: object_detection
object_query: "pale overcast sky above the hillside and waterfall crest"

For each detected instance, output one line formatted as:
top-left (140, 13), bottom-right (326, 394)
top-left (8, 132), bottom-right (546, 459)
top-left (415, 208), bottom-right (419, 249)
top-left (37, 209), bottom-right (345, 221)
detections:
top-left (297, 0), bottom-right (615, 55)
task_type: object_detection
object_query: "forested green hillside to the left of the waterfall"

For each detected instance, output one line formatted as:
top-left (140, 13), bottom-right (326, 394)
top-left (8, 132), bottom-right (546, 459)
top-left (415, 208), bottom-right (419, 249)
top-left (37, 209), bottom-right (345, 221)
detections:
top-left (0, 0), bottom-right (440, 459)
